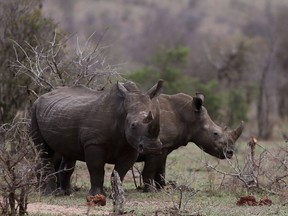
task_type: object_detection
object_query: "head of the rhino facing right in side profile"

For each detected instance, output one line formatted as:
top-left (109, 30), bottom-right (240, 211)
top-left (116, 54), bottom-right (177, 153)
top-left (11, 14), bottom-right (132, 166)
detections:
top-left (191, 94), bottom-right (243, 159)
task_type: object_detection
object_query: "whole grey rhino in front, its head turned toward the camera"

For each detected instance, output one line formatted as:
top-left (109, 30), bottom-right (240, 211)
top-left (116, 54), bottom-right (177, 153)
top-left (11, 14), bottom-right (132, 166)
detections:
top-left (31, 80), bottom-right (163, 195)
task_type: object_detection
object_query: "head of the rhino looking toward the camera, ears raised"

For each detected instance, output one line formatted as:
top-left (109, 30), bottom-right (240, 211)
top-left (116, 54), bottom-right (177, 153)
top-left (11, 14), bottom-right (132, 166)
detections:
top-left (118, 80), bottom-right (163, 154)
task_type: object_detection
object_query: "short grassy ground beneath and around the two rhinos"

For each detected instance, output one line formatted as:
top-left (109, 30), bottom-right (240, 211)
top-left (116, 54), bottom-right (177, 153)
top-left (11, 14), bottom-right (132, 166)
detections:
top-left (28, 141), bottom-right (288, 216)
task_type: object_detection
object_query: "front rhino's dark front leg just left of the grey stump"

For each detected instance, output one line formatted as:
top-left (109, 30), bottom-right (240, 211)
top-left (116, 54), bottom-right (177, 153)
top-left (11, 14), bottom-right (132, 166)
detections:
top-left (85, 145), bottom-right (106, 196)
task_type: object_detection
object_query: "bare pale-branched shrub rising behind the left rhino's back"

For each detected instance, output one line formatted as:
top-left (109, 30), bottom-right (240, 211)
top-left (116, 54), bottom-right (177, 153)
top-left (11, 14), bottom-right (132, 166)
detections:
top-left (12, 32), bottom-right (121, 92)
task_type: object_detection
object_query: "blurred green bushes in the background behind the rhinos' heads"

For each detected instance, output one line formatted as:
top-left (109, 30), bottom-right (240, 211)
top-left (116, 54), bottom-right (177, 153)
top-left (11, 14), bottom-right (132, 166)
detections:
top-left (125, 47), bottom-right (250, 126)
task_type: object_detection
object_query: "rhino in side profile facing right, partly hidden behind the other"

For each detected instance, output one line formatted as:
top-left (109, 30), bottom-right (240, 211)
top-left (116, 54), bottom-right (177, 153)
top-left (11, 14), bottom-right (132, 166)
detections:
top-left (137, 93), bottom-right (243, 192)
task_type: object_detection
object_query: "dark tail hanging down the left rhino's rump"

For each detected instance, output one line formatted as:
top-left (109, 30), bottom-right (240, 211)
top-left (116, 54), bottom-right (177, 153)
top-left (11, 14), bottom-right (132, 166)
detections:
top-left (30, 101), bottom-right (54, 157)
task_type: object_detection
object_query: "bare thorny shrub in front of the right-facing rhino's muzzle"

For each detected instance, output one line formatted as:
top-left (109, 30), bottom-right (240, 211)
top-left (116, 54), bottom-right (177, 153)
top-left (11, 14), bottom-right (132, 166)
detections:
top-left (206, 137), bottom-right (288, 199)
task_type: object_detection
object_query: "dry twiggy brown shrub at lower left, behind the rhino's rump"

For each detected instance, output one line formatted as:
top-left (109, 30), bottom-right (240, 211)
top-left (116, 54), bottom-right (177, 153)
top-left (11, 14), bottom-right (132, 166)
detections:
top-left (0, 119), bottom-right (41, 216)
